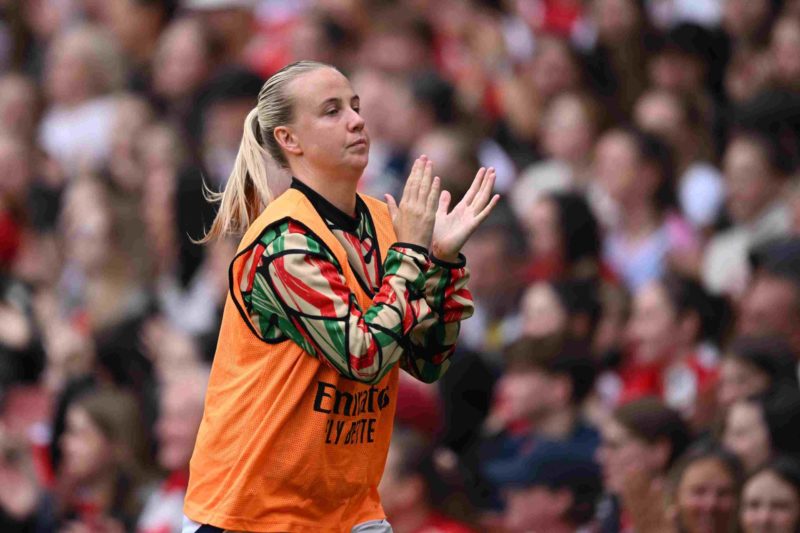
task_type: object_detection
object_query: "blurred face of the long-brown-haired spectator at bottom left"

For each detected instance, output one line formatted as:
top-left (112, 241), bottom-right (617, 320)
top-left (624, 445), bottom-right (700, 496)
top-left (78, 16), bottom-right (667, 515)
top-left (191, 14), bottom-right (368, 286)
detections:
top-left (61, 406), bottom-right (113, 483)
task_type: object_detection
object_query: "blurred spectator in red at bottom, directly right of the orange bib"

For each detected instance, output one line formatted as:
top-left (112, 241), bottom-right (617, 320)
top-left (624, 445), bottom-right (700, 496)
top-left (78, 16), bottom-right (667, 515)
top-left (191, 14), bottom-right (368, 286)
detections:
top-left (378, 427), bottom-right (472, 533)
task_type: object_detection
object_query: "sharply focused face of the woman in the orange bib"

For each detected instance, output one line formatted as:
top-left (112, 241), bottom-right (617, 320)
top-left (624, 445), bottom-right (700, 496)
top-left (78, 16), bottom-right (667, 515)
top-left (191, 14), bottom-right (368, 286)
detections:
top-left (276, 68), bottom-right (369, 177)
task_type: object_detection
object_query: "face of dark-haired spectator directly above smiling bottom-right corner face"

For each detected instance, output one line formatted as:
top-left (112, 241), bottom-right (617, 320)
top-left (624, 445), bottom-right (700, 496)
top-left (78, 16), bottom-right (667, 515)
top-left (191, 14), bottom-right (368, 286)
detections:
top-left (722, 401), bottom-right (771, 472)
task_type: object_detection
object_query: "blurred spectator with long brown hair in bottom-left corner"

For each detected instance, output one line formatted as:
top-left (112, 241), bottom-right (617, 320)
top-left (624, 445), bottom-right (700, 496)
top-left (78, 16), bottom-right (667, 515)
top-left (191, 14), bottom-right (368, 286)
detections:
top-left (0, 389), bottom-right (155, 531)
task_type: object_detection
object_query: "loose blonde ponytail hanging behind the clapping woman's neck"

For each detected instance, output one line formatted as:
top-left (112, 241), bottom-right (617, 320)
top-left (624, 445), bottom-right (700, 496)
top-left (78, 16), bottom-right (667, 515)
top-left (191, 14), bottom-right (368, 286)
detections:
top-left (199, 107), bottom-right (272, 243)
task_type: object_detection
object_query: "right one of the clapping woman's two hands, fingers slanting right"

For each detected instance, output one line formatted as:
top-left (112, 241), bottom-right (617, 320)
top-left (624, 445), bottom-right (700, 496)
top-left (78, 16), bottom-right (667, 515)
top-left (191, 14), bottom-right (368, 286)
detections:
top-left (431, 167), bottom-right (500, 262)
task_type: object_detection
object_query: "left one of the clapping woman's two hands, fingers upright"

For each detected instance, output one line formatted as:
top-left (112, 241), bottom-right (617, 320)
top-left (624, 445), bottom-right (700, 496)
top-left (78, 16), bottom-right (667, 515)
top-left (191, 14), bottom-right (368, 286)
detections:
top-left (384, 155), bottom-right (440, 249)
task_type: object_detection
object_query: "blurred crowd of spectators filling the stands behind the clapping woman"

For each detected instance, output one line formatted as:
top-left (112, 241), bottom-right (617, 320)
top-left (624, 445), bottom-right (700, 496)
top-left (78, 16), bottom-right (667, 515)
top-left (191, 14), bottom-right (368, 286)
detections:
top-left (0, 0), bottom-right (800, 533)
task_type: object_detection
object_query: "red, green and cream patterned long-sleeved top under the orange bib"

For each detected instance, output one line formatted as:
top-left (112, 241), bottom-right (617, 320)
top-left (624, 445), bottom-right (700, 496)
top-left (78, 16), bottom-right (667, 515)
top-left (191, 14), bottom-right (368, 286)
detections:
top-left (239, 182), bottom-right (473, 383)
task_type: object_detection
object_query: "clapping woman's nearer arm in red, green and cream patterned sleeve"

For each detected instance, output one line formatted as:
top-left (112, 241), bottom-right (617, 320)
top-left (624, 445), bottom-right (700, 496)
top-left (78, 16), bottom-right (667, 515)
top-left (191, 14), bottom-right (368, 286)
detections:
top-left (244, 218), bottom-right (432, 383)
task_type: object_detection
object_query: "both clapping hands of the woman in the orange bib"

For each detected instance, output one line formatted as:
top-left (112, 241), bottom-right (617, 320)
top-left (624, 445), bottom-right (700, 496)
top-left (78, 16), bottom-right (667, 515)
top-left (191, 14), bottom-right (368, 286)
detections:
top-left (385, 155), bottom-right (500, 261)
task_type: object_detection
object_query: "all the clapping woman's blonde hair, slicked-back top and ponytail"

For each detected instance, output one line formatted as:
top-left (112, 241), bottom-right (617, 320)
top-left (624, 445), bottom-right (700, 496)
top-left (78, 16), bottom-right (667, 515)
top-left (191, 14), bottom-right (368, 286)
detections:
top-left (199, 61), bottom-right (335, 243)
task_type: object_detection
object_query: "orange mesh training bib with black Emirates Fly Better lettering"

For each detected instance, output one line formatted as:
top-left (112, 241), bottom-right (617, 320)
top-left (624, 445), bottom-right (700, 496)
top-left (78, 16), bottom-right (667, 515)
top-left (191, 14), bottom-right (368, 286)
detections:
top-left (184, 189), bottom-right (399, 532)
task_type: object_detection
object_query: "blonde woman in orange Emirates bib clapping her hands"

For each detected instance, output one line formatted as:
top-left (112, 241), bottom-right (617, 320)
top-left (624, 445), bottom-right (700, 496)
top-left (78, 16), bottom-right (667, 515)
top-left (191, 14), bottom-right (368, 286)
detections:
top-left (184, 61), bottom-right (498, 532)
